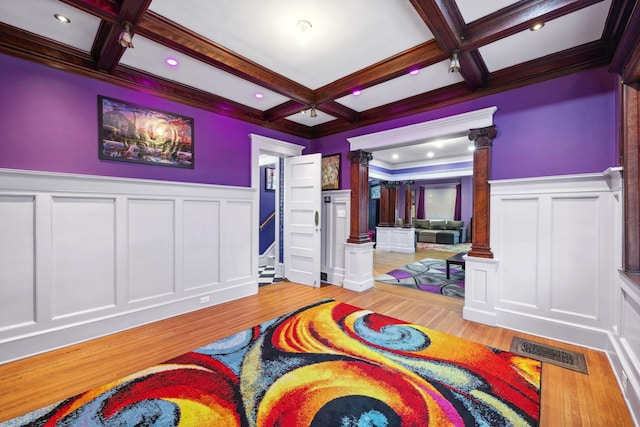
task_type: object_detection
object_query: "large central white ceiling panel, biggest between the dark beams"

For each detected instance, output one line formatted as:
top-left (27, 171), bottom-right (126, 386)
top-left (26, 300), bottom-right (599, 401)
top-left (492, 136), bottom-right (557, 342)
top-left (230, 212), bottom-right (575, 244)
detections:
top-left (150, 0), bottom-right (433, 89)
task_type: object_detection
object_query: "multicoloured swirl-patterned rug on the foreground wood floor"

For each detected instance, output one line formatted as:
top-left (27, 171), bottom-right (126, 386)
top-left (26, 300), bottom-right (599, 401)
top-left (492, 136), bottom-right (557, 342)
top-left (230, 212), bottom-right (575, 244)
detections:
top-left (0, 300), bottom-right (540, 427)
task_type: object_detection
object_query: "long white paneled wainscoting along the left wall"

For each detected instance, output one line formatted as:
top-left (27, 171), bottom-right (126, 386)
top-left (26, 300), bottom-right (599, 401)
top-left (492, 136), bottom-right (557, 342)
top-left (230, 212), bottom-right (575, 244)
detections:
top-left (0, 169), bottom-right (258, 363)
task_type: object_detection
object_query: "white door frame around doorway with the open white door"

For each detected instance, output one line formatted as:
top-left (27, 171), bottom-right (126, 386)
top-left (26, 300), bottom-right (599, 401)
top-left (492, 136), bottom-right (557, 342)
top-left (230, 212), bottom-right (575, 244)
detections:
top-left (249, 133), bottom-right (306, 285)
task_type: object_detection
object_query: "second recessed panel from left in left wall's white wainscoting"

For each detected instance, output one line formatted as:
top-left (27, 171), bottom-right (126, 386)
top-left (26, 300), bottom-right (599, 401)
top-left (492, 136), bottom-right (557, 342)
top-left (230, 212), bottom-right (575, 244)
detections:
top-left (51, 196), bottom-right (116, 318)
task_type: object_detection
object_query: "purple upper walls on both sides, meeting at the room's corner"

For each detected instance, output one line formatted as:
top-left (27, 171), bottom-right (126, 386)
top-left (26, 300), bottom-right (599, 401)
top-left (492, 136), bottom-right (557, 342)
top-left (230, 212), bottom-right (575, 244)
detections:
top-left (0, 54), bottom-right (618, 188)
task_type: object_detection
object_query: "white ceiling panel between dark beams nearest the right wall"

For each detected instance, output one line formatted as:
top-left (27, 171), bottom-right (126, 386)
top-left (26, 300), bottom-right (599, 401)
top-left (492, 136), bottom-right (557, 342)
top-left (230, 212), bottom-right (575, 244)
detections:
top-left (478, 0), bottom-right (611, 72)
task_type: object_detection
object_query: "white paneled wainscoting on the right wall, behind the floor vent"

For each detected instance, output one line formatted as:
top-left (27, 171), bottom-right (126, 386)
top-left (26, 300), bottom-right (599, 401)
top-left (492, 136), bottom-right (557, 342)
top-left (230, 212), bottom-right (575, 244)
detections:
top-left (464, 170), bottom-right (621, 350)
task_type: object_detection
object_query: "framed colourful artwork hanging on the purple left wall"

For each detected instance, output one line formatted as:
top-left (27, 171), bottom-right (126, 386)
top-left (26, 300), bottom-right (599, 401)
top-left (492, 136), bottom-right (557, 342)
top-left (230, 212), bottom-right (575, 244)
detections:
top-left (98, 96), bottom-right (194, 169)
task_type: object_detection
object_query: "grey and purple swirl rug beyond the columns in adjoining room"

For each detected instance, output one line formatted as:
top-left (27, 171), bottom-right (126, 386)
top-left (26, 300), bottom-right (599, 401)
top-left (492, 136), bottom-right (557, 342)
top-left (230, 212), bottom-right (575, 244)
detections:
top-left (374, 258), bottom-right (464, 298)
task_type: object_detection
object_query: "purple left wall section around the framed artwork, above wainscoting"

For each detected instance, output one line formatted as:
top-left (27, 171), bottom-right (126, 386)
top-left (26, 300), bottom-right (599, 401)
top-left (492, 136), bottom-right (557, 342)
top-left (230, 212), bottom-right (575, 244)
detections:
top-left (0, 54), bottom-right (309, 187)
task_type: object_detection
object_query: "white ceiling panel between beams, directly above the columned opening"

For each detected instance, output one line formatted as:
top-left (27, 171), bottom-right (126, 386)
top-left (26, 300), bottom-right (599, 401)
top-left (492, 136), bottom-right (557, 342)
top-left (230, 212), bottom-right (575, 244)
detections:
top-left (336, 60), bottom-right (463, 112)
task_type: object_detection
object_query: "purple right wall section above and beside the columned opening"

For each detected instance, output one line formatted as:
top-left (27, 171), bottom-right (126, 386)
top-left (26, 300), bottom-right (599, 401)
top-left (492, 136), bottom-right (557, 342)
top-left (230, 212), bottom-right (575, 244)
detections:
top-left (311, 67), bottom-right (618, 188)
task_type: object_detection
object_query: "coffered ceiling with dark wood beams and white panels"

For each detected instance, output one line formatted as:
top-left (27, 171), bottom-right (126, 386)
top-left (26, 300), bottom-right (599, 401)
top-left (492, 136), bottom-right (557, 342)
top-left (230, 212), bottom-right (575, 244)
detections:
top-left (0, 0), bottom-right (640, 139)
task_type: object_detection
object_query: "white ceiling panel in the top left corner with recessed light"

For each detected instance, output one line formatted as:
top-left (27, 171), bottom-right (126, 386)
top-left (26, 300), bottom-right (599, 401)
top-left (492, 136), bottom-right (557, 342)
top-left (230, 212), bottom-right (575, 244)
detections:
top-left (0, 0), bottom-right (100, 52)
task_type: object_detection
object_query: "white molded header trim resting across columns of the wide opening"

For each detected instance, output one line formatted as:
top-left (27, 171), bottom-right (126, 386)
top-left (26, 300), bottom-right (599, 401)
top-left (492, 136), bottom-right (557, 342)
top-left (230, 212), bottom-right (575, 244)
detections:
top-left (347, 107), bottom-right (498, 151)
